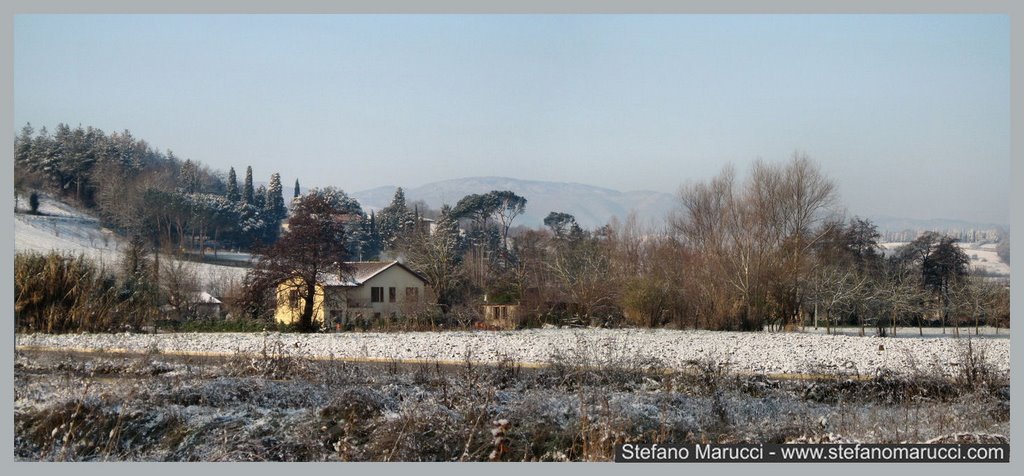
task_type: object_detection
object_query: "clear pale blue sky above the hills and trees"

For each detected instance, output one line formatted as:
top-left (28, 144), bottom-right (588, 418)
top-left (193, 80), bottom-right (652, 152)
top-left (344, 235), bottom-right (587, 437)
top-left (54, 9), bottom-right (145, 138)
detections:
top-left (13, 14), bottom-right (1011, 224)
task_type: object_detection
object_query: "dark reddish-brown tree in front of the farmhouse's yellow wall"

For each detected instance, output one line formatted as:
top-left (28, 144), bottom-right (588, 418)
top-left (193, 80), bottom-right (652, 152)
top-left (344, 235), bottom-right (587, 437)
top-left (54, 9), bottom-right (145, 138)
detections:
top-left (246, 193), bottom-right (348, 332)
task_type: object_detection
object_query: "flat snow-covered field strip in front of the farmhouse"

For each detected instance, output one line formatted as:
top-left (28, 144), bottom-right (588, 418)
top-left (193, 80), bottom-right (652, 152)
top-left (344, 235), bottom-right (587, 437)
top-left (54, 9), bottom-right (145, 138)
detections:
top-left (16, 329), bottom-right (1010, 376)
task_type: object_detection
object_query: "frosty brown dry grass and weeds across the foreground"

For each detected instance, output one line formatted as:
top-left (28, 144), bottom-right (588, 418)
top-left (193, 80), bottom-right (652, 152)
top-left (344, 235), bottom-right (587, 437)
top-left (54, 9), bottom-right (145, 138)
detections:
top-left (15, 341), bottom-right (1009, 462)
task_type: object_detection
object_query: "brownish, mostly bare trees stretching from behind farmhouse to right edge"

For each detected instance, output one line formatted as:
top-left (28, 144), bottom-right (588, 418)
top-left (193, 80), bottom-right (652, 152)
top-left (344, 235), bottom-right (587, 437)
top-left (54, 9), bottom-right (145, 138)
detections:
top-left (237, 155), bottom-right (1009, 335)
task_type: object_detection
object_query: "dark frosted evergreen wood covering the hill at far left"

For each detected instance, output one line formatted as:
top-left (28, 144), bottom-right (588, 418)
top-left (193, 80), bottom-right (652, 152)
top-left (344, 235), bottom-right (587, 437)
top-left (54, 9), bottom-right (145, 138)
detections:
top-left (14, 124), bottom-right (296, 253)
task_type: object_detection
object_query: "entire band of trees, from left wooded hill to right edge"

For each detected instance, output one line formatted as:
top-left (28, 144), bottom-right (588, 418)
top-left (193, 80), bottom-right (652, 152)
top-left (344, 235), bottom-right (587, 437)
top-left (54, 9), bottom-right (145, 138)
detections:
top-left (14, 125), bottom-right (1010, 334)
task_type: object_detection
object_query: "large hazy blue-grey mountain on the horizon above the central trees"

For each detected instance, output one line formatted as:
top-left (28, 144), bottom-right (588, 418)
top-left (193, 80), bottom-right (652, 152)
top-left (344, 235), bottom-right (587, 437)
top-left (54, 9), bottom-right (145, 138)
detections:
top-left (351, 177), bottom-right (677, 228)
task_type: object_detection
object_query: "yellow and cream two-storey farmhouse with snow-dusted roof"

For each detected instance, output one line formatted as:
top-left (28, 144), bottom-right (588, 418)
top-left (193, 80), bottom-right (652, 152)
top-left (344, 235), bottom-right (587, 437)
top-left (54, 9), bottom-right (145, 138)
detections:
top-left (274, 261), bottom-right (427, 329)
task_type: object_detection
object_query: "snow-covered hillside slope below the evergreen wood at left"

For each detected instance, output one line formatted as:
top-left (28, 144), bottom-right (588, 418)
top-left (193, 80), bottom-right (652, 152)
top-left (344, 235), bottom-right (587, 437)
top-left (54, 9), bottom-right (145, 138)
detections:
top-left (14, 196), bottom-right (248, 287)
